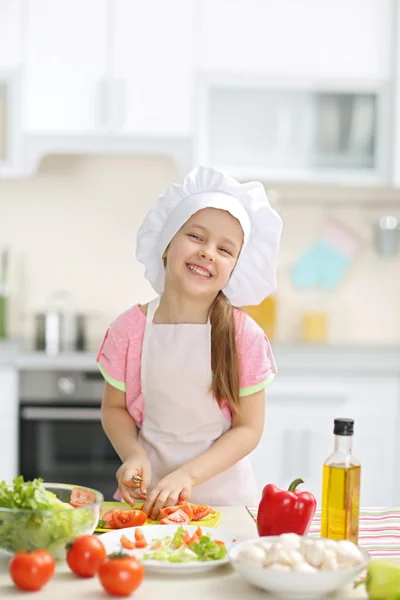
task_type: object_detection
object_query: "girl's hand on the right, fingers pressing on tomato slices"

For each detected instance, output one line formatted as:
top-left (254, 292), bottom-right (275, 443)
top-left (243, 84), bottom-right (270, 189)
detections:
top-left (142, 469), bottom-right (193, 520)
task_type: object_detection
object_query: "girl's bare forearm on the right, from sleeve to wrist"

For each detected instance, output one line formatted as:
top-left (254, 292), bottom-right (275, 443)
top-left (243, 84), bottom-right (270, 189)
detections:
top-left (181, 390), bottom-right (265, 485)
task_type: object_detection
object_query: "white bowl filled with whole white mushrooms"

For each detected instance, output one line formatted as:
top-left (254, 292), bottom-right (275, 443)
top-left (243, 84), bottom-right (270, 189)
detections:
top-left (229, 533), bottom-right (370, 600)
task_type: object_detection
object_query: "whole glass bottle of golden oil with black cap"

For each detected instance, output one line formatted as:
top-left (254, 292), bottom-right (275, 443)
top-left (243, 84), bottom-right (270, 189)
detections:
top-left (321, 419), bottom-right (361, 544)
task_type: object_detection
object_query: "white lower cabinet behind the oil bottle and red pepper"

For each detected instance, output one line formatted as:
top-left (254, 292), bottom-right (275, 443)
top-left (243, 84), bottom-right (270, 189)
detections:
top-left (251, 375), bottom-right (400, 506)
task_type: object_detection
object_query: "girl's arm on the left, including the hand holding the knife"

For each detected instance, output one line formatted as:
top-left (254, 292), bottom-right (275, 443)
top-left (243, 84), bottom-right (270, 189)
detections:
top-left (101, 382), bottom-right (151, 504)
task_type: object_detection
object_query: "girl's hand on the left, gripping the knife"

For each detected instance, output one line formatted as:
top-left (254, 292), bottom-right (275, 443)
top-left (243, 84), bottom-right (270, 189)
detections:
top-left (116, 453), bottom-right (151, 506)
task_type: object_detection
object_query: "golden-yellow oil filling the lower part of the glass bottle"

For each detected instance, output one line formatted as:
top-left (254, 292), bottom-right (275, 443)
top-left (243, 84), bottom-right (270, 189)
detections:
top-left (321, 465), bottom-right (361, 544)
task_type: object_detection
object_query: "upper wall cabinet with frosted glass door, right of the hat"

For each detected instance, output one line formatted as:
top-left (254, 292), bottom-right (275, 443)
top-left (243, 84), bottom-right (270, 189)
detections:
top-left (196, 76), bottom-right (390, 184)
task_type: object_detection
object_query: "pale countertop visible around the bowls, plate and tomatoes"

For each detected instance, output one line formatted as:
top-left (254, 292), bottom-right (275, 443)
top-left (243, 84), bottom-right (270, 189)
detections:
top-left (0, 507), bottom-right (367, 600)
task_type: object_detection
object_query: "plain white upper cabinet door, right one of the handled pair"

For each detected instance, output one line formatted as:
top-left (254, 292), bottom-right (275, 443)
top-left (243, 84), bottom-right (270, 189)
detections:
top-left (112, 0), bottom-right (195, 136)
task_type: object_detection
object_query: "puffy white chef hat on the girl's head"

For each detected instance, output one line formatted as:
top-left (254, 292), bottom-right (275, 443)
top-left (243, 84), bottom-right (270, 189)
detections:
top-left (136, 167), bottom-right (282, 306)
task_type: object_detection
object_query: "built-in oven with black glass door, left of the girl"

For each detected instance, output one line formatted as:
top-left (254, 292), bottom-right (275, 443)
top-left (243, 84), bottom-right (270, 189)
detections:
top-left (19, 370), bottom-right (121, 500)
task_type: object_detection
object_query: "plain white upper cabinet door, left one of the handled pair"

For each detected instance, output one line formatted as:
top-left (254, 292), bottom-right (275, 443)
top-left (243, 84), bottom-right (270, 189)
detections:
top-left (23, 0), bottom-right (107, 133)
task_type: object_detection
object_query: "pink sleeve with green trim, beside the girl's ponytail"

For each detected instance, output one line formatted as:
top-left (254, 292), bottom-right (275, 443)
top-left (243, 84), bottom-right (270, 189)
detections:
top-left (237, 313), bottom-right (277, 396)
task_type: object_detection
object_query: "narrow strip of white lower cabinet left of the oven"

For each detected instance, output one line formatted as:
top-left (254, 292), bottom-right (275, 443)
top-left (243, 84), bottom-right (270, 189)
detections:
top-left (0, 366), bottom-right (18, 482)
